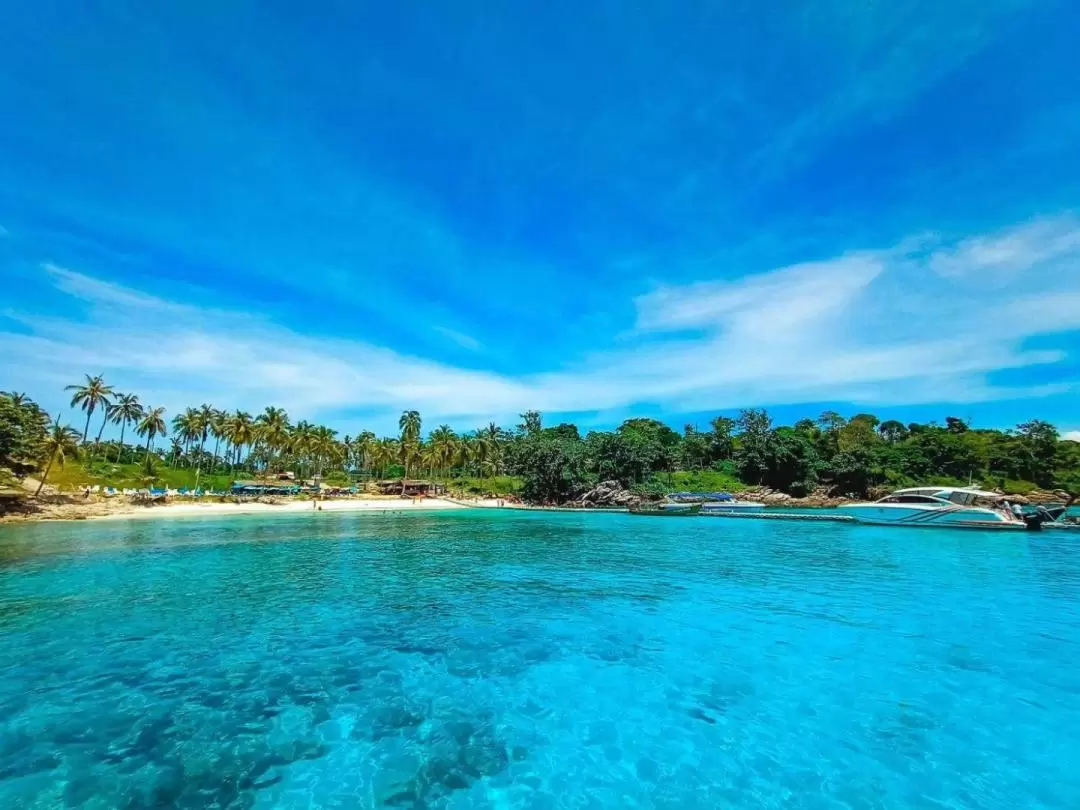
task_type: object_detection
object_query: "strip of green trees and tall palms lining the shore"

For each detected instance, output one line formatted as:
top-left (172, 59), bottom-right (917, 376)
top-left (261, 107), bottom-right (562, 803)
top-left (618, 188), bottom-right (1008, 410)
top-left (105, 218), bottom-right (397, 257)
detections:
top-left (0, 376), bottom-right (1080, 502)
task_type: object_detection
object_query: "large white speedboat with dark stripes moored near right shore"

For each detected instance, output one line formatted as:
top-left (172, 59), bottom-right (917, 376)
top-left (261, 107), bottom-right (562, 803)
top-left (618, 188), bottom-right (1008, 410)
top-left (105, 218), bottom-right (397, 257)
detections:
top-left (836, 487), bottom-right (1027, 529)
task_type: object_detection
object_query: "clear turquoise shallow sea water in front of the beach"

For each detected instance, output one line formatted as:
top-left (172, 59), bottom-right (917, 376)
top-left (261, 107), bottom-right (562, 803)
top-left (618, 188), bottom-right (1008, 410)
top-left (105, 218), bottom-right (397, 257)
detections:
top-left (0, 512), bottom-right (1080, 810)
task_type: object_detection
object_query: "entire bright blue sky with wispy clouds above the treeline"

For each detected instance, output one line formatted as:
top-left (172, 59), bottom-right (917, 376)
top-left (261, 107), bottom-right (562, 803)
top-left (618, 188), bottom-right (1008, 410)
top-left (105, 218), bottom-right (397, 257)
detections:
top-left (0, 0), bottom-right (1080, 431)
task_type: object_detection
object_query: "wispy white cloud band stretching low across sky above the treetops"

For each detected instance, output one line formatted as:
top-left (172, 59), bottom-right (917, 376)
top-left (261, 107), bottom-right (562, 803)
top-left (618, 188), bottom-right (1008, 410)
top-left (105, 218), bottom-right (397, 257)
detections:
top-left (0, 213), bottom-right (1080, 432)
